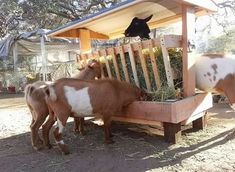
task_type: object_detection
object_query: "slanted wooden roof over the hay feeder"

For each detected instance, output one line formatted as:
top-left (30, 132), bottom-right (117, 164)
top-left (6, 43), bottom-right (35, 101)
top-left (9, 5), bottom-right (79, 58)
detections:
top-left (48, 0), bottom-right (217, 39)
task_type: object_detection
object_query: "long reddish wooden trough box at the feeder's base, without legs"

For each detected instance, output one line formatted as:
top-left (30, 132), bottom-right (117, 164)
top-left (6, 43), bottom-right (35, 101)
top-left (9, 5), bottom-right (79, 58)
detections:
top-left (117, 94), bottom-right (213, 123)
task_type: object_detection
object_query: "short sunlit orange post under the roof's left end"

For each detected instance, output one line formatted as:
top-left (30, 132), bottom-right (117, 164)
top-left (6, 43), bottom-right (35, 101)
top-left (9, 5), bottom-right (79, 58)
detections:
top-left (78, 29), bottom-right (91, 53)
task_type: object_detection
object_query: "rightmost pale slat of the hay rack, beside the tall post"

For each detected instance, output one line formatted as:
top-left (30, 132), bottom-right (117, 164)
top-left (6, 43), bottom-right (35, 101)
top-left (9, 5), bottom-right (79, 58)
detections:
top-left (161, 37), bottom-right (174, 89)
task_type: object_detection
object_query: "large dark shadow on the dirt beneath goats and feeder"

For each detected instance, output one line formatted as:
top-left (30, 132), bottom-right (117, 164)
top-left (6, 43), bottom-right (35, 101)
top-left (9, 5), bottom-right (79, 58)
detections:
top-left (0, 118), bottom-right (235, 172)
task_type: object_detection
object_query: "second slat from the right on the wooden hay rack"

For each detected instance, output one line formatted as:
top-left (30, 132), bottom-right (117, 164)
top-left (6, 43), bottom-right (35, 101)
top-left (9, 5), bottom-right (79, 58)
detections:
top-left (149, 40), bottom-right (161, 89)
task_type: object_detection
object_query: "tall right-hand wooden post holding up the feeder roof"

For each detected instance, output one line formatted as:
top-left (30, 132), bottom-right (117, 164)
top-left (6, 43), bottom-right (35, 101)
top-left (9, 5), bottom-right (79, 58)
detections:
top-left (182, 5), bottom-right (195, 97)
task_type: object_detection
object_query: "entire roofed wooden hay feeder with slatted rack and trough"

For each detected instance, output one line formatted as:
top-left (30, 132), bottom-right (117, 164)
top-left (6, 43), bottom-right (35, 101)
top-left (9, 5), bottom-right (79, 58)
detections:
top-left (48, 0), bottom-right (216, 143)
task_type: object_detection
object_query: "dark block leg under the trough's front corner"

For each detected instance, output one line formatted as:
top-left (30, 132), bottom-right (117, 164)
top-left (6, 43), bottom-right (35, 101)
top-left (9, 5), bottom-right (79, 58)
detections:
top-left (163, 122), bottom-right (181, 144)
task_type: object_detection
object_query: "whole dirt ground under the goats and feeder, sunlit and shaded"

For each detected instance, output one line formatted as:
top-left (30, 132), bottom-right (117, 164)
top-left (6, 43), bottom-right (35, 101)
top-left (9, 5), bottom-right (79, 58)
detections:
top-left (0, 95), bottom-right (235, 172)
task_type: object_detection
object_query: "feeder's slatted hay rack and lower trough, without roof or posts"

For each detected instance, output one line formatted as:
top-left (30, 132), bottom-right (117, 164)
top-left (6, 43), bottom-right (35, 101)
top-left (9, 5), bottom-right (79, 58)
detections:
top-left (75, 35), bottom-right (212, 143)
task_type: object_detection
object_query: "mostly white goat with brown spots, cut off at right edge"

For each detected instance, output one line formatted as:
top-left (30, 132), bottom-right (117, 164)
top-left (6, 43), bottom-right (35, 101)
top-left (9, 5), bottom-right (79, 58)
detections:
top-left (195, 54), bottom-right (235, 109)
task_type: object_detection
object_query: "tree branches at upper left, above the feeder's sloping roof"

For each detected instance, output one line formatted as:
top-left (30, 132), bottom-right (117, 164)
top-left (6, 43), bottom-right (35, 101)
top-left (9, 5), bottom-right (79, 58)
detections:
top-left (0, 0), bottom-right (123, 38)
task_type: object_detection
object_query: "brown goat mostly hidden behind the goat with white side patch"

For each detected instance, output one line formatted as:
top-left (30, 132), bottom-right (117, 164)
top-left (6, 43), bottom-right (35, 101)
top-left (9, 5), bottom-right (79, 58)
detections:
top-left (25, 60), bottom-right (101, 150)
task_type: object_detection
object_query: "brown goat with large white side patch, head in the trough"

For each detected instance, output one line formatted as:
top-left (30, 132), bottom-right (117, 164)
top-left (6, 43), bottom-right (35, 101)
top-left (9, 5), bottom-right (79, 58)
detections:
top-left (42, 78), bottom-right (146, 154)
